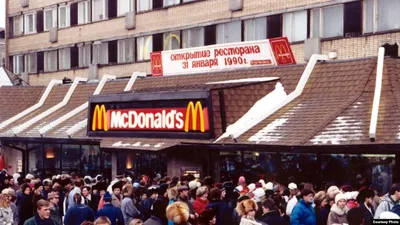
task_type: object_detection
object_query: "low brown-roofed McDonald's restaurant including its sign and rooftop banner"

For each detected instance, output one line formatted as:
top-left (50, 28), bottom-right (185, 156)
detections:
top-left (0, 40), bottom-right (400, 193)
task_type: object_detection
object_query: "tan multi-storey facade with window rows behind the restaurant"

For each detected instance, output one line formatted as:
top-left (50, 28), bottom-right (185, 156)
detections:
top-left (6, 0), bottom-right (400, 85)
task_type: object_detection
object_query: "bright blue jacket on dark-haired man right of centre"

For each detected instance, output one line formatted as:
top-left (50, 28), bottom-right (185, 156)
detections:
top-left (290, 199), bottom-right (317, 225)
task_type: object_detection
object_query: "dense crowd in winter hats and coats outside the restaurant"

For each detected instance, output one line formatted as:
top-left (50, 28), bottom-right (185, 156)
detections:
top-left (0, 170), bottom-right (400, 225)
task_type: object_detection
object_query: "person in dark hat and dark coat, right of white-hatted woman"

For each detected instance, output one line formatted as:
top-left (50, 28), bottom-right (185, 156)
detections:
top-left (358, 188), bottom-right (375, 225)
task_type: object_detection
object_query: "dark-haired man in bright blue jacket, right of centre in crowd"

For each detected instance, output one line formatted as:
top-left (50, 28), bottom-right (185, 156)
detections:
top-left (290, 189), bottom-right (317, 225)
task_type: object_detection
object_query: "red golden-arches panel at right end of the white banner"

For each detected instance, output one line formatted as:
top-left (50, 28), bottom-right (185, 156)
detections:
top-left (269, 37), bottom-right (296, 66)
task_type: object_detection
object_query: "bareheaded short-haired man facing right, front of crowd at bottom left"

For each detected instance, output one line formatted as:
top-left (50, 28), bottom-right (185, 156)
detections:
top-left (24, 199), bottom-right (59, 225)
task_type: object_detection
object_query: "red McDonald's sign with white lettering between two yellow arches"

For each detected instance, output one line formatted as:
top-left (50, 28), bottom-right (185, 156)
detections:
top-left (91, 101), bottom-right (210, 133)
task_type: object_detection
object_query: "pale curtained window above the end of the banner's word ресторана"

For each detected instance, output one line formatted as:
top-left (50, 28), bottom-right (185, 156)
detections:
top-left (244, 17), bottom-right (267, 41)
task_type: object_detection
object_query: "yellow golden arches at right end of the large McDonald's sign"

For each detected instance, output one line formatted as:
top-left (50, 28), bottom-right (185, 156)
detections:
top-left (185, 101), bottom-right (209, 132)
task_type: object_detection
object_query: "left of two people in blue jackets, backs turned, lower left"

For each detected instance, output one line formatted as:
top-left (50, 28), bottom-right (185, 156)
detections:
top-left (64, 193), bottom-right (95, 225)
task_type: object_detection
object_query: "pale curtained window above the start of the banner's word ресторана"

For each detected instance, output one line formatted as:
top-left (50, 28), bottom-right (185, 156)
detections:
top-left (217, 21), bottom-right (242, 44)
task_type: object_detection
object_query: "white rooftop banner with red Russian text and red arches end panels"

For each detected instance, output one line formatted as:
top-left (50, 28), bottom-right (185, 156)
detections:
top-left (151, 37), bottom-right (296, 76)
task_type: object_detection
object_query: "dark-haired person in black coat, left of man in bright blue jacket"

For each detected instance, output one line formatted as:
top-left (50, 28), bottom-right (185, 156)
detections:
top-left (260, 198), bottom-right (289, 225)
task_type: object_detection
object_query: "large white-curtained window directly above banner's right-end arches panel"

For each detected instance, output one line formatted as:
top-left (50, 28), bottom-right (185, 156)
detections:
top-left (283, 10), bottom-right (307, 42)
